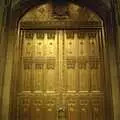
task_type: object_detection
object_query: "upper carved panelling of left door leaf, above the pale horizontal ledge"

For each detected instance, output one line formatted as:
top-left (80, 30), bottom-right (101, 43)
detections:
top-left (21, 30), bottom-right (58, 91)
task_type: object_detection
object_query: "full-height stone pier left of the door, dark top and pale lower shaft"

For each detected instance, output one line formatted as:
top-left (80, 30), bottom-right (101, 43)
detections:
top-left (0, 0), bottom-right (16, 120)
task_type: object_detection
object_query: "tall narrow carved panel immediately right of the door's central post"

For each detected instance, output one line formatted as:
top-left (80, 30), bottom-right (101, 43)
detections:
top-left (63, 31), bottom-right (77, 91)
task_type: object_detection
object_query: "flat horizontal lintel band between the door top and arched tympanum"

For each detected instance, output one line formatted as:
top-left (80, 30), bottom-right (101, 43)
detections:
top-left (20, 20), bottom-right (102, 29)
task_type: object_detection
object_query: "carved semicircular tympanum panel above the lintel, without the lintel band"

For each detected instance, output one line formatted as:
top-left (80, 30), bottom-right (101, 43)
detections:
top-left (20, 3), bottom-right (101, 22)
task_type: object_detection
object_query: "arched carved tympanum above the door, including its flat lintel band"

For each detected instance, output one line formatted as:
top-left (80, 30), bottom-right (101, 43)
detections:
top-left (19, 2), bottom-right (102, 29)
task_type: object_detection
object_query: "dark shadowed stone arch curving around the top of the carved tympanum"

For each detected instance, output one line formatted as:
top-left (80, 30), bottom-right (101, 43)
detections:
top-left (11, 0), bottom-right (110, 25)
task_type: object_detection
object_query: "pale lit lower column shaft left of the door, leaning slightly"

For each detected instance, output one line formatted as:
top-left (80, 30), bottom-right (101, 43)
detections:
top-left (1, 30), bottom-right (16, 120)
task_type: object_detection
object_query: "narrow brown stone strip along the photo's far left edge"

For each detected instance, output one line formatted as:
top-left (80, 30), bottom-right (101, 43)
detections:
top-left (0, 0), bottom-right (8, 116)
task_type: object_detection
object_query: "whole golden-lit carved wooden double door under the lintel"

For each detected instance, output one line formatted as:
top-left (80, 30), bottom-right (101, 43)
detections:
top-left (14, 29), bottom-right (105, 120)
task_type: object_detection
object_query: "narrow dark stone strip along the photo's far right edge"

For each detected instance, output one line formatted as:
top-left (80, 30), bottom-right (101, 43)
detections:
top-left (113, 0), bottom-right (120, 120)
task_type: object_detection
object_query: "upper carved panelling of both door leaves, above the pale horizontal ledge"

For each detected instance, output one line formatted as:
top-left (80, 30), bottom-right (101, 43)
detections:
top-left (19, 30), bottom-right (104, 92)
